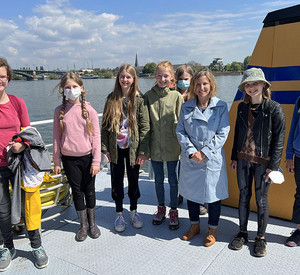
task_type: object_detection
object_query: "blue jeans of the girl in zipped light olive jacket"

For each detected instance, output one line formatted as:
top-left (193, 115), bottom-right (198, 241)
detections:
top-left (151, 160), bottom-right (178, 208)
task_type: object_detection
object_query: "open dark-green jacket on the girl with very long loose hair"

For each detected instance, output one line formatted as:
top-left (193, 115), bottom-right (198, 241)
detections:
top-left (101, 93), bottom-right (150, 166)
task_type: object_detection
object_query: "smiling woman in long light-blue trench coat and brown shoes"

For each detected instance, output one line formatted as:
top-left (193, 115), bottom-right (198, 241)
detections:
top-left (176, 69), bottom-right (230, 246)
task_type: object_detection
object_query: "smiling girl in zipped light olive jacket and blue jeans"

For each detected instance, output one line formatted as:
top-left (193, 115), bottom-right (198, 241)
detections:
top-left (145, 61), bottom-right (184, 229)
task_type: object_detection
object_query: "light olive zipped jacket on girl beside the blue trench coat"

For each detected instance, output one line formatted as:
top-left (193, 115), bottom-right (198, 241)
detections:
top-left (144, 85), bottom-right (184, 161)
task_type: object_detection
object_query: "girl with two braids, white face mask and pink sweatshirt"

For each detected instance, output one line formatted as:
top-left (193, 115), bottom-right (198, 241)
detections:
top-left (53, 73), bottom-right (101, 241)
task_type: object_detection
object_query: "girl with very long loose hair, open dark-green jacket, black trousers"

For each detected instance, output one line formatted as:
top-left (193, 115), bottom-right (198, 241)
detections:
top-left (101, 64), bottom-right (149, 232)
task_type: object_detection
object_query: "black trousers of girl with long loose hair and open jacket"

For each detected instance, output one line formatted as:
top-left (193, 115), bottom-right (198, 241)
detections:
top-left (110, 147), bottom-right (141, 212)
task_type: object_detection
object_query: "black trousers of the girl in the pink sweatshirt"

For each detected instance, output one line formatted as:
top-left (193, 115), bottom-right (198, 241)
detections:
top-left (61, 154), bottom-right (96, 211)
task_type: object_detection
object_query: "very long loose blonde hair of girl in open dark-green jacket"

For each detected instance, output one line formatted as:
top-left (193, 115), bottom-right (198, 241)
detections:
top-left (102, 64), bottom-right (139, 135)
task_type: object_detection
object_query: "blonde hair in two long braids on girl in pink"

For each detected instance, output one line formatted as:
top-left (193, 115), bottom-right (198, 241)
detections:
top-left (54, 72), bottom-right (94, 134)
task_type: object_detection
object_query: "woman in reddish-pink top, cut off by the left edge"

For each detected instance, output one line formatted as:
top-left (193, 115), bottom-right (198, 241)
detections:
top-left (0, 57), bottom-right (49, 272)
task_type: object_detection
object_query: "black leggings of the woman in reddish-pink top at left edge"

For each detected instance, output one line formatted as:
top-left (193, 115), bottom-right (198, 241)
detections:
top-left (0, 167), bottom-right (42, 249)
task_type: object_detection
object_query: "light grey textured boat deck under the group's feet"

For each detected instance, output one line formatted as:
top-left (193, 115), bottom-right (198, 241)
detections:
top-left (5, 172), bottom-right (300, 275)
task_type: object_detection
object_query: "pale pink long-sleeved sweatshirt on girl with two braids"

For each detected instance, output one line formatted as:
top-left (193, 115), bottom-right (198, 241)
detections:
top-left (53, 102), bottom-right (101, 166)
